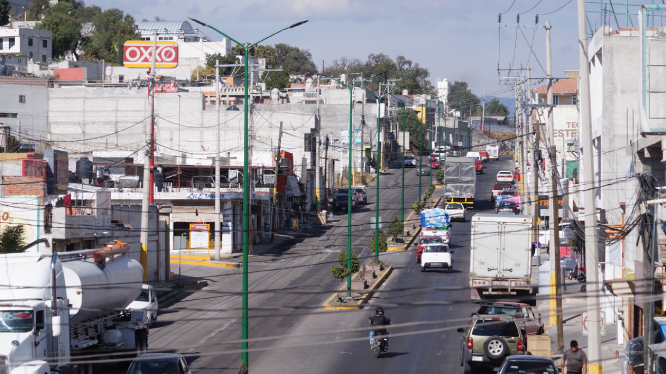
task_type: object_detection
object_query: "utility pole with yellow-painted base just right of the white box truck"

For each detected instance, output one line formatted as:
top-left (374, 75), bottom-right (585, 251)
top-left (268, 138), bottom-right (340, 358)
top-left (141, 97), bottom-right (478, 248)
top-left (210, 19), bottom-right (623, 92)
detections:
top-left (546, 21), bottom-right (564, 353)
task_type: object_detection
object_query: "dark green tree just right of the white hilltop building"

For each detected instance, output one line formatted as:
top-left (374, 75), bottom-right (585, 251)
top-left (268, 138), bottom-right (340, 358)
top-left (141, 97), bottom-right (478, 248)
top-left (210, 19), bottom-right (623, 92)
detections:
top-left (35, 2), bottom-right (81, 59)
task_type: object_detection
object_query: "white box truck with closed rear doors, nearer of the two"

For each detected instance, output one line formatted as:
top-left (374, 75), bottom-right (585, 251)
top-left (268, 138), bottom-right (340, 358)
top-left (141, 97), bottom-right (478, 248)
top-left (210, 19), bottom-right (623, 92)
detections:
top-left (469, 214), bottom-right (532, 299)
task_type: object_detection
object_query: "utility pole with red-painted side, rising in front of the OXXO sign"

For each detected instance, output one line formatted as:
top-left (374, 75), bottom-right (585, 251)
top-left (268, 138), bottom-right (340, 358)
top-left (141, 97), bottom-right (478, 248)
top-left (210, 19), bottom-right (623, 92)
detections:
top-left (139, 30), bottom-right (157, 283)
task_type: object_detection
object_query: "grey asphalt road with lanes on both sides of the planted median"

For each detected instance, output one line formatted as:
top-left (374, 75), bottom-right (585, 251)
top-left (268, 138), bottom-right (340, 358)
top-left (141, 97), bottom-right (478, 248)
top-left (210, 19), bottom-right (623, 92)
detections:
top-left (102, 156), bottom-right (512, 374)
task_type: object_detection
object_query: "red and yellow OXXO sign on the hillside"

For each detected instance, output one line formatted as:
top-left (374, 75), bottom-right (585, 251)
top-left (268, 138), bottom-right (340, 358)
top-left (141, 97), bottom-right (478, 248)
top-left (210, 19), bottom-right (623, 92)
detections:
top-left (123, 40), bottom-right (178, 69)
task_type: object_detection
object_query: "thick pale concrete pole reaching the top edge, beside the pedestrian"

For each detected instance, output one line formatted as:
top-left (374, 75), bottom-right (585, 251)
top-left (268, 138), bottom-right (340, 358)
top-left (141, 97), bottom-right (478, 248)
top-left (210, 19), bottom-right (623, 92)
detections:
top-left (578, 0), bottom-right (602, 374)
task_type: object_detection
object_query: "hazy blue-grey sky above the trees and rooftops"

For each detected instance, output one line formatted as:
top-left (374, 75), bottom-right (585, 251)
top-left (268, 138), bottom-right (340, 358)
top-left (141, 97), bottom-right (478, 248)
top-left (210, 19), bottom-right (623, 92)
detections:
top-left (86, 0), bottom-right (598, 97)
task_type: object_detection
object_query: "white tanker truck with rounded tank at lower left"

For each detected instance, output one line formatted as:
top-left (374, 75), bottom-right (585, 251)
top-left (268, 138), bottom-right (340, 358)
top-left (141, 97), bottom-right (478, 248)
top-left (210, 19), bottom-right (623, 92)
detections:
top-left (0, 241), bottom-right (148, 374)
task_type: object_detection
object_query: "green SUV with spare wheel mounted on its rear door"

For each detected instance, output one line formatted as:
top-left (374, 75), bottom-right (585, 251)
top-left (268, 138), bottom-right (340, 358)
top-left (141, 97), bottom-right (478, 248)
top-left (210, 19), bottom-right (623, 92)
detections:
top-left (458, 315), bottom-right (527, 373)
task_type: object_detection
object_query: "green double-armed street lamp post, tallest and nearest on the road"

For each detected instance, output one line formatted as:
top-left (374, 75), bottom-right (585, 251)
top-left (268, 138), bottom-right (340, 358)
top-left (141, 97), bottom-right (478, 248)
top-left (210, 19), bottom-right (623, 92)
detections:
top-left (188, 17), bottom-right (307, 367)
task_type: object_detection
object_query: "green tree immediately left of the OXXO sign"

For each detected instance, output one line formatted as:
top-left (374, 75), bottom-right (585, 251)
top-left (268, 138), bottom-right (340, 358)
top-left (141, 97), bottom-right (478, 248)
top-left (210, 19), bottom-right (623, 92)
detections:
top-left (83, 8), bottom-right (139, 65)
